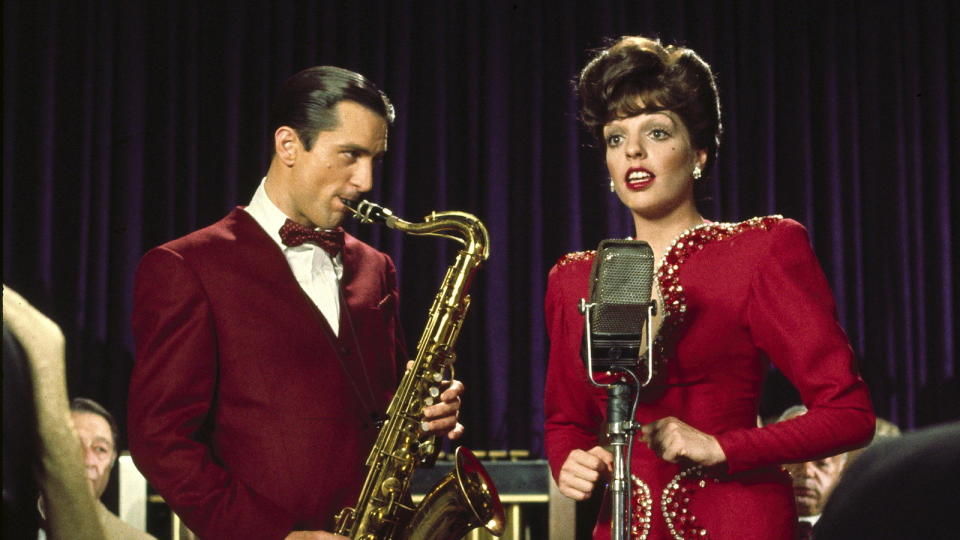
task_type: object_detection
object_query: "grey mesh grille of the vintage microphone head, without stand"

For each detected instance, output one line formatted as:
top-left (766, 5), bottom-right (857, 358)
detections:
top-left (590, 240), bottom-right (653, 335)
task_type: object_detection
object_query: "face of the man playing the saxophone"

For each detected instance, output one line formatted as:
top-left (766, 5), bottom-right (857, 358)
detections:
top-left (268, 101), bottom-right (387, 229)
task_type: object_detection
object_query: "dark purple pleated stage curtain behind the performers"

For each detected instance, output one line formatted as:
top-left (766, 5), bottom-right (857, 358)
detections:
top-left (3, 0), bottom-right (960, 455)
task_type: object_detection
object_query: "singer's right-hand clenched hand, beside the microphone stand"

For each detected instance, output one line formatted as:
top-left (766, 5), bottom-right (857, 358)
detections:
top-left (641, 416), bottom-right (727, 467)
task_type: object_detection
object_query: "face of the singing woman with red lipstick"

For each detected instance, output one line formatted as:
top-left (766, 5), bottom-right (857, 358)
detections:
top-left (603, 105), bottom-right (707, 219)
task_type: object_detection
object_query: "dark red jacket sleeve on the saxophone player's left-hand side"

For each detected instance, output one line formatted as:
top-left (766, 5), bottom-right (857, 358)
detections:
top-left (129, 247), bottom-right (294, 539)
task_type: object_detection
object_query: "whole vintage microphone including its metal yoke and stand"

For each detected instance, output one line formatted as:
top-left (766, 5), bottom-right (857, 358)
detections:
top-left (579, 240), bottom-right (657, 540)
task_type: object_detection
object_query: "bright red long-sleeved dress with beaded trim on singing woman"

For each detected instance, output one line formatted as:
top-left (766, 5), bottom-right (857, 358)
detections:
top-left (545, 216), bottom-right (874, 540)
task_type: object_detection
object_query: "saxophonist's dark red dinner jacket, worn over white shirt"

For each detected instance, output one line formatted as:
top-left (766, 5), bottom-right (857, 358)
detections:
top-left (128, 208), bottom-right (404, 540)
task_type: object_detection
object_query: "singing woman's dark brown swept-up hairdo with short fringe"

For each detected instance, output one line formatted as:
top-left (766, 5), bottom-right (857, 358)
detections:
top-left (577, 36), bottom-right (721, 173)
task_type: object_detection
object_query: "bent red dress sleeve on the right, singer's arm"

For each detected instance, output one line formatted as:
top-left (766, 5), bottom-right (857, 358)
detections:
top-left (717, 220), bottom-right (875, 473)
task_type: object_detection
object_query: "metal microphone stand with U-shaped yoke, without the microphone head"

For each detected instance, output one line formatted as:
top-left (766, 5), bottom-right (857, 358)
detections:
top-left (579, 298), bottom-right (657, 540)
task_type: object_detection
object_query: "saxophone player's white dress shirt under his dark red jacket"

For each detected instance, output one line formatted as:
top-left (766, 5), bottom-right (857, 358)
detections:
top-left (245, 178), bottom-right (343, 334)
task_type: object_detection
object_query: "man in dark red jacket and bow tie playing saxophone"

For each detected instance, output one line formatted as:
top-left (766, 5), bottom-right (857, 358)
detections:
top-left (129, 66), bottom-right (463, 540)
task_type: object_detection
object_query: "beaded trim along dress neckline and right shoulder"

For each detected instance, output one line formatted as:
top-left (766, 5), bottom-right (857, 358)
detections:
top-left (656, 215), bottom-right (783, 357)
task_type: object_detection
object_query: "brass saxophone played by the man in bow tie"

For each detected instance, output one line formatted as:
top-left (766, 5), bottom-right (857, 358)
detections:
top-left (334, 201), bottom-right (505, 540)
